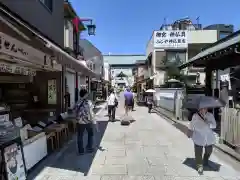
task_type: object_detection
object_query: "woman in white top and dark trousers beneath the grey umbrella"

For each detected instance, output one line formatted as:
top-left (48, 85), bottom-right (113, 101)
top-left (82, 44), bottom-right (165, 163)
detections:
top-left (188, 108), bottom-right (216, 174)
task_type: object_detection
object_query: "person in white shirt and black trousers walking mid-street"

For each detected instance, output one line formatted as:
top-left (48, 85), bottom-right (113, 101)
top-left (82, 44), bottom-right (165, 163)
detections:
top-left (107, 89), bottom-right (118, 122)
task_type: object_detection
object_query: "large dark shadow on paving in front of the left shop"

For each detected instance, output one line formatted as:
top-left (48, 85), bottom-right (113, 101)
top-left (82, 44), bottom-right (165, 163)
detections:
top-left (28, 121), bottom-right (108, 180)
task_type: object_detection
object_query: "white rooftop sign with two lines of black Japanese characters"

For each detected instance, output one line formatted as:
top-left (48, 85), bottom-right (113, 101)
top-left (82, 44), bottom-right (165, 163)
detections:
top-left (154, 30), bottom-right (188, 49)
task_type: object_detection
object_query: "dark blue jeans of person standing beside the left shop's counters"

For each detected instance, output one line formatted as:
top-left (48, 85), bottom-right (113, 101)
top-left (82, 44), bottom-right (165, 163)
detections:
top-left (77, 123), bottom-right (94, 153)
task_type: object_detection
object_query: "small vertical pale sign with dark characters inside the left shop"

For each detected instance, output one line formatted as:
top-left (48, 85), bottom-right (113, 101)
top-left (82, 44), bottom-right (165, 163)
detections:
top-left (48, 79), bottom-right (57, 104)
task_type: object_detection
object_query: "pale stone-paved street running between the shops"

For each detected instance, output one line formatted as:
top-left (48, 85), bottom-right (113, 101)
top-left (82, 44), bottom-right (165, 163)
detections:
top-left (31, 95), bottom-right (240, 180)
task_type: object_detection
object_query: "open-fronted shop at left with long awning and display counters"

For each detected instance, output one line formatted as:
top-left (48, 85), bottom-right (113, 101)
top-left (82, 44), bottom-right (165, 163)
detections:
top-left (0, 1), bottom-right (95, 179)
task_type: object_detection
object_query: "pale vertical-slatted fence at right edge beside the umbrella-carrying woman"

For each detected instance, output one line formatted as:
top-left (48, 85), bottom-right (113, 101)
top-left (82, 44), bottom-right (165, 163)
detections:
top-left (221, 107), bottom-right (240, 147)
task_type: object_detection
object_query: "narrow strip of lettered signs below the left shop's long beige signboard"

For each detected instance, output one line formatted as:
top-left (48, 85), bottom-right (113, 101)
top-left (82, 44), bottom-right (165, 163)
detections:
top-left (0, 63), bottom-right (36, 76)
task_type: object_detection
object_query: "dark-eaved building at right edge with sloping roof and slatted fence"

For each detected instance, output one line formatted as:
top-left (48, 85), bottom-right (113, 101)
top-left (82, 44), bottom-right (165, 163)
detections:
top-left (179, 31), bottom-right (240, 153)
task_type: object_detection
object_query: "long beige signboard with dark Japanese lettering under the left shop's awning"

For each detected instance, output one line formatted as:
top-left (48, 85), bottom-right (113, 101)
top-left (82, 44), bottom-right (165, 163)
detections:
top-left (0, 32), bottom-right (53, 67)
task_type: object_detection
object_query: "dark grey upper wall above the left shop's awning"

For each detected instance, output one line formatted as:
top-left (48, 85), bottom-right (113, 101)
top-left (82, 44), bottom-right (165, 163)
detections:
top-left (0, 0), bottom-right (64, 47)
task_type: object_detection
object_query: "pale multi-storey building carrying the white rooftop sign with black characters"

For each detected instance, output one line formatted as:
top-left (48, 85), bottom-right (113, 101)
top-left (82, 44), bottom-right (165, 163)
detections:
top-left (146, 18), bottom-right (232, 86)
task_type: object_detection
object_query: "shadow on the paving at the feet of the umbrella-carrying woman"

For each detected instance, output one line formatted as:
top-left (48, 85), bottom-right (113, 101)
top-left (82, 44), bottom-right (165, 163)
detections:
top-left (183, 158), bottom-right (221, 172)
